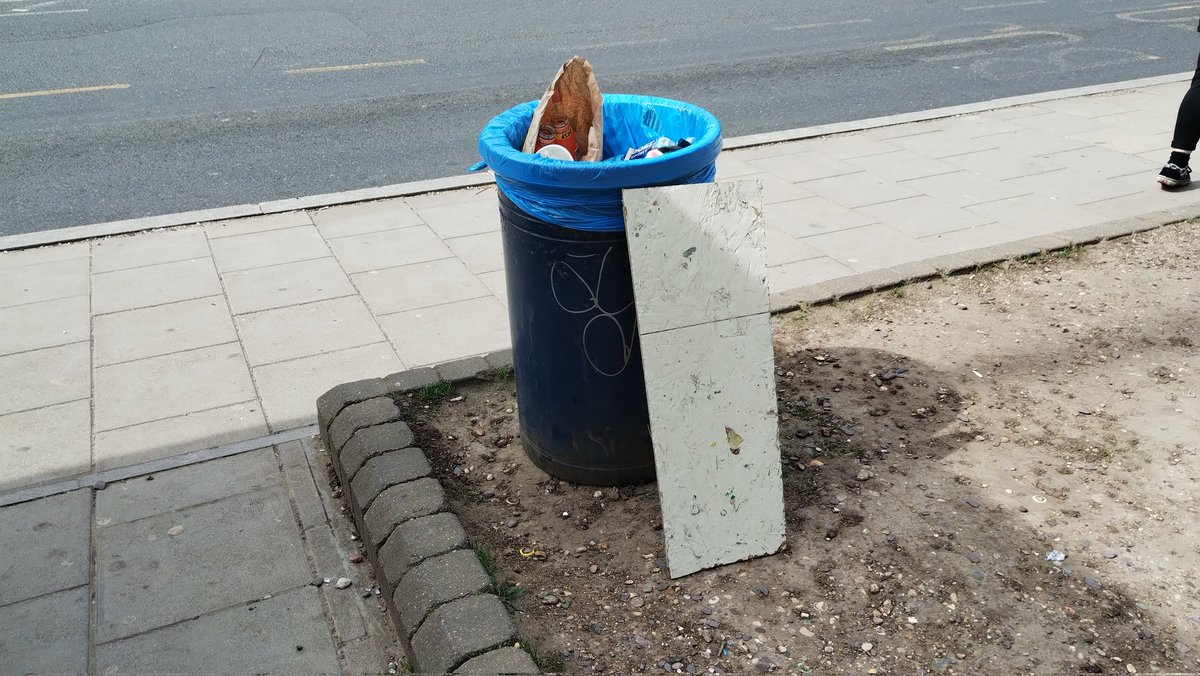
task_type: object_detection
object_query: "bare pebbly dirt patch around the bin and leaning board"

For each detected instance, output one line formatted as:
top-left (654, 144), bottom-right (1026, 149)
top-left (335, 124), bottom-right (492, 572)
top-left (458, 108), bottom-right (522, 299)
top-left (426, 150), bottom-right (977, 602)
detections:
top-left (404, 223), bottom-right (1200, 674)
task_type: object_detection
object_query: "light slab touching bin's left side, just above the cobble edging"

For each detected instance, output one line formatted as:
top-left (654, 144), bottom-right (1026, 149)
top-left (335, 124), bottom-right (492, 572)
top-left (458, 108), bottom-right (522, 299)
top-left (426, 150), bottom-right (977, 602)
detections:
top-left (379, 298), bottom-right (511, 366)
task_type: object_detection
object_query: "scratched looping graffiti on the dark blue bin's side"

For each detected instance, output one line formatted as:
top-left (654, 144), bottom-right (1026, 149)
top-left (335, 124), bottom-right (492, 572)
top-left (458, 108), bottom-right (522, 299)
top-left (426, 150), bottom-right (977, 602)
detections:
top-left (550, 246), bottom-right (637, 377)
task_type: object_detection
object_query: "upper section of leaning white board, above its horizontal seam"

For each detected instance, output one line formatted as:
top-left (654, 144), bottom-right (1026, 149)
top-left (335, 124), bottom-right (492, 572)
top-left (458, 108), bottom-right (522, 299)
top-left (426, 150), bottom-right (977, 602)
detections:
top-left (624, 181), bottom-right (770, 333)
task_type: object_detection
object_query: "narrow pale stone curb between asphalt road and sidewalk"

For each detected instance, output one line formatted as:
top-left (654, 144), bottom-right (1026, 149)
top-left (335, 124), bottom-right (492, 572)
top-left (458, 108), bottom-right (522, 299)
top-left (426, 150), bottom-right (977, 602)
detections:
top-left (0, 73), bottom-right (1192, 251)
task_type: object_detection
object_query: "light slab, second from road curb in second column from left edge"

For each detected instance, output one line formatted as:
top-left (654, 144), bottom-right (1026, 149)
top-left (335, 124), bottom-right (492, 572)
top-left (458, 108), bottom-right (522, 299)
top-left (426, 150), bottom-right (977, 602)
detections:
top-left (91, 258), bottom-right (222, 315)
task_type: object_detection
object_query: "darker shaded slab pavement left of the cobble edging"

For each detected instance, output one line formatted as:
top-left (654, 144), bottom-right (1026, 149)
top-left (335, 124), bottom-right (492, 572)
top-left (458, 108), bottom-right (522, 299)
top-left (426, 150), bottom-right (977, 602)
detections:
top-left (0, 439), bottom-right (401, 674)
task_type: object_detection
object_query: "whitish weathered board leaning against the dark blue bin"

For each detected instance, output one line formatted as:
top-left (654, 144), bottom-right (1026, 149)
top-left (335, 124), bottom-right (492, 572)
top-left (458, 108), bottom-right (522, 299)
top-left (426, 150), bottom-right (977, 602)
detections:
top-left (624, 181), bottom-right (784, 578)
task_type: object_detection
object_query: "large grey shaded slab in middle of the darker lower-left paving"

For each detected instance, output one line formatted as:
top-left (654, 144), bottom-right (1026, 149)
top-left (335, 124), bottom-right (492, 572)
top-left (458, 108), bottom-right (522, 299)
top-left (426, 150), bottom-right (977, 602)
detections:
top-left (95, 487), bottom-right (312, 650)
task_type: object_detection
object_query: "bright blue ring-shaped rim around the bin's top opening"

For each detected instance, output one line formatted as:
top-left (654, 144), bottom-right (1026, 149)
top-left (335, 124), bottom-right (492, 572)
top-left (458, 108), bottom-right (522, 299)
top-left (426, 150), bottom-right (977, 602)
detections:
top-left (479, 94), bottom-right (721, 190)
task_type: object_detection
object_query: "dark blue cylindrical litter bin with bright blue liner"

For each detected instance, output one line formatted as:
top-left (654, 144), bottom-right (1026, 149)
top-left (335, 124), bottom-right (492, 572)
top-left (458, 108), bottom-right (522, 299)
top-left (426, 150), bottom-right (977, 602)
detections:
top-left (479, 94), bottom-right (721, 486)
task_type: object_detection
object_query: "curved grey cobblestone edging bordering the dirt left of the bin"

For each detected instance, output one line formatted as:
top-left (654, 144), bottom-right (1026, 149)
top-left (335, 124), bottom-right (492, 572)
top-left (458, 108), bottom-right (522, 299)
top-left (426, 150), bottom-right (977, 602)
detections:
top-left (317, 351), bottom-right (538, 674)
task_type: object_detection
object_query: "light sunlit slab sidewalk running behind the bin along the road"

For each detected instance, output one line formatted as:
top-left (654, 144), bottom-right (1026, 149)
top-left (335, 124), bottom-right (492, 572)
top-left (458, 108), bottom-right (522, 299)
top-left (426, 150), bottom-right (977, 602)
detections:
top-left (0, 82), bottom-right (1200, 492)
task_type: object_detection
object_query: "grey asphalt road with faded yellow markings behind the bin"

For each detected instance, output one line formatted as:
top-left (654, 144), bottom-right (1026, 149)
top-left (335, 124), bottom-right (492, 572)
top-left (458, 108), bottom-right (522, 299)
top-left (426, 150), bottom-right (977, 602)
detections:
top-left (0, 0), bottom-right (1200, 235)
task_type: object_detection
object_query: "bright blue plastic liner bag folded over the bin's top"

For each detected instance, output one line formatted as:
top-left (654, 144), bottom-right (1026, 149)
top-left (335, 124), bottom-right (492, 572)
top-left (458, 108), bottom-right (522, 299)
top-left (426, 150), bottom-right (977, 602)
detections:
top-left (479, 94), bottom-right (721, 232)
